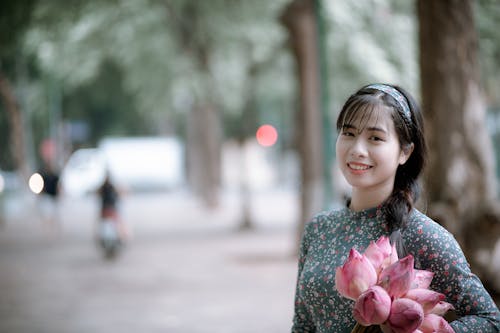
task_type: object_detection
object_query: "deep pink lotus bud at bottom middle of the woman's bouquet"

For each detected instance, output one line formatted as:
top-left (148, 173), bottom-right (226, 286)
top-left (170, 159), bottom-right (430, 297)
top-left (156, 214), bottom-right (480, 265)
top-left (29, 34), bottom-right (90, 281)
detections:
top-left (387, 298), bottom-right (424, 333)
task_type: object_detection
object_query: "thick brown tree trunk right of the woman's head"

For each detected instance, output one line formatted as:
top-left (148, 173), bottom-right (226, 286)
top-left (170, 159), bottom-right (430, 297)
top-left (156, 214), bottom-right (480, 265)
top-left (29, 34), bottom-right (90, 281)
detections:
top-left (418, 0), bottom-right (500, 290)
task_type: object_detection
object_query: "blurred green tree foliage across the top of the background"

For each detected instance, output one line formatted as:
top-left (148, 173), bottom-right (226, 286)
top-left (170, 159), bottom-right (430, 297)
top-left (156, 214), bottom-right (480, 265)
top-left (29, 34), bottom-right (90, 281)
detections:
top-left (0, 0), bottom-right (500, 167)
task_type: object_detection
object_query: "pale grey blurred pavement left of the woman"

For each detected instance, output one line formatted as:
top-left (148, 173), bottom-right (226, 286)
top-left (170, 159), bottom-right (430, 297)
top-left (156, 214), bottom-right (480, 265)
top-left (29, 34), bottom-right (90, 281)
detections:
top-left (0, 190), bottom-right (298, 333)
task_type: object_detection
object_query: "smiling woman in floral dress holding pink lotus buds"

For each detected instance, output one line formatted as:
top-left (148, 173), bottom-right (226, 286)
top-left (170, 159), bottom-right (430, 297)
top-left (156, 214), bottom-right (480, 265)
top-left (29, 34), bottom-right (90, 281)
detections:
top-left (292, 84), bottom-right (500, 333)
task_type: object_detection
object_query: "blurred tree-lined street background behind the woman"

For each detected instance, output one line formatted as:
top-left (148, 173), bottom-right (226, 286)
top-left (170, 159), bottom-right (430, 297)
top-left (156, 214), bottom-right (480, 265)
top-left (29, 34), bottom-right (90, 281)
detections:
top-left (0, 0), bottom-right (500, 332)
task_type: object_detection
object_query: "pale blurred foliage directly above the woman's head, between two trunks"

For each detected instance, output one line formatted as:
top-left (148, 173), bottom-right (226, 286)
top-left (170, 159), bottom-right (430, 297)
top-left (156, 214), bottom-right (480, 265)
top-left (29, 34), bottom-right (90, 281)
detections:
top-left (324, 0), bottom-right (418, 113)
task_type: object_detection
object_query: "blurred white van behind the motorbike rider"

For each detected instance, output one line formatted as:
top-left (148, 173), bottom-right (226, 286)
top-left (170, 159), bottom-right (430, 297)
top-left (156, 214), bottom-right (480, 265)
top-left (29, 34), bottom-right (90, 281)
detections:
top-left (61, 137), bottom-right (185, 195)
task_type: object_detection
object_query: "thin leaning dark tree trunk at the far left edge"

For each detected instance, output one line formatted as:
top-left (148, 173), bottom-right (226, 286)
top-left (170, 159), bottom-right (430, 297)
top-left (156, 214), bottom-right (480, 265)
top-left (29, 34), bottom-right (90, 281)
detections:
top-left (0, 71), bottom-right (29, 179)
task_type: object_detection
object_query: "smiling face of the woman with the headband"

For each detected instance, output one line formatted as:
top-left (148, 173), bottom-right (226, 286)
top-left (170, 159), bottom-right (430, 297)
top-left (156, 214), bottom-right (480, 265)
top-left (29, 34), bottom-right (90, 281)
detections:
top-left (336, 108), bottom-right (409, 201)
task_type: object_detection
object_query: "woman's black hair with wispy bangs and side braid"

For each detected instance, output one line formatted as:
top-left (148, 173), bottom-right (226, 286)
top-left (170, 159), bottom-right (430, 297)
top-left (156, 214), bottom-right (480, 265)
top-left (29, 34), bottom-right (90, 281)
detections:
top-left (337, 84), bottom-right (427, 258)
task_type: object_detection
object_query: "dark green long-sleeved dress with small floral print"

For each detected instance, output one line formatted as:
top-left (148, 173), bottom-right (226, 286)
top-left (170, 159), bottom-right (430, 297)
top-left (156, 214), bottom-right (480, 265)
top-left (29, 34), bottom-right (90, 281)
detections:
top-left (292, 208), bottom-right (500, 333)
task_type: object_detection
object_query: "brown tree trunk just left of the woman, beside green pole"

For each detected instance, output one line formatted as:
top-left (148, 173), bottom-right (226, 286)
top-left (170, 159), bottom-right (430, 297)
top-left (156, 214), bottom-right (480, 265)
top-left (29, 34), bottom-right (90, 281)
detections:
top-left (281, 0), bottom-right (324, 244)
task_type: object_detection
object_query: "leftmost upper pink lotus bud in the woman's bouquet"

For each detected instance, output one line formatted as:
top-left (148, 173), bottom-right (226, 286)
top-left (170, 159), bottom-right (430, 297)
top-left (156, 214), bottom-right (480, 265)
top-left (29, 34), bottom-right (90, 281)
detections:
top-left (335, 249), bottom-right (377, 300)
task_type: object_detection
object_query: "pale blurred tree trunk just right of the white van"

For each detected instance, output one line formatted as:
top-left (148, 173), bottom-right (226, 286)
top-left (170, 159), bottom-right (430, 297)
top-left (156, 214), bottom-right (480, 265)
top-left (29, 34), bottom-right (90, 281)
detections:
top-left (164, 1), bottom-right (222, 208)
